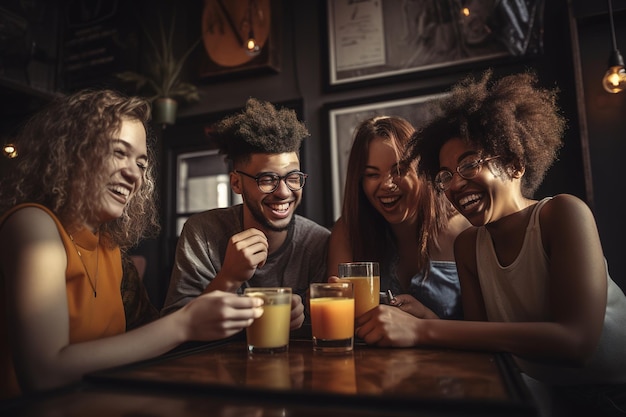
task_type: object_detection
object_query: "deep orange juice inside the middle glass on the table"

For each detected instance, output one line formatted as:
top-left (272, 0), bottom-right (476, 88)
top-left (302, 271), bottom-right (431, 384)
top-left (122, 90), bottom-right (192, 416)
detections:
top-left (311, 297), bottom-right (354, 340)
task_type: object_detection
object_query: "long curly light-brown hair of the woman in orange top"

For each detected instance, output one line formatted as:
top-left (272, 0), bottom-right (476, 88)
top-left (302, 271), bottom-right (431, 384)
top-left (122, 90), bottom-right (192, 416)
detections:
top-left (0, 90), bottom-right (160, 249)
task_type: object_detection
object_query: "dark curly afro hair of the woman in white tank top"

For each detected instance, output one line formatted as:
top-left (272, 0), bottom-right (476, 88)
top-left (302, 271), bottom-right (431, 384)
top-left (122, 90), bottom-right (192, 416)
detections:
top-left (405, 70), bottom-right (566, 198)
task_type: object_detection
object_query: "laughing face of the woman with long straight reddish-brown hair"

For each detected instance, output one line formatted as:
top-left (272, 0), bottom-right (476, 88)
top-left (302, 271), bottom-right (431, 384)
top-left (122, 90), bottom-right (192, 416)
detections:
top-left (362, 137), bottom-right (419, 225)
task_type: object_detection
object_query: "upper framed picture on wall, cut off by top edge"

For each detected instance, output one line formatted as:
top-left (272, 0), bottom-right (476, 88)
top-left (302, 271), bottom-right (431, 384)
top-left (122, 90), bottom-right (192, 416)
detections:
top-left (326, 0), bottom-right (545, 87)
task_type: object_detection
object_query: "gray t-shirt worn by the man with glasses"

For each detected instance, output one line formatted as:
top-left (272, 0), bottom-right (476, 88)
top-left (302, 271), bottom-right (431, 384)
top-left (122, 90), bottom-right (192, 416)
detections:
top-left (161, 204), bottom-right (330, 315)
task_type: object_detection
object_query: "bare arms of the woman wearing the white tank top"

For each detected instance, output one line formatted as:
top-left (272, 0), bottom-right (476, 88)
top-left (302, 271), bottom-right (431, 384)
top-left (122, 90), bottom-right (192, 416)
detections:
top-left (357, 196), bottom-right (607, 366)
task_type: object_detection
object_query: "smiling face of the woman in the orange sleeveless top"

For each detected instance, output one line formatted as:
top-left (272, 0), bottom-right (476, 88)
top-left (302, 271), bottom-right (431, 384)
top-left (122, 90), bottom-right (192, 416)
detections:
top-left (89, 119), bottom-right (148, 230)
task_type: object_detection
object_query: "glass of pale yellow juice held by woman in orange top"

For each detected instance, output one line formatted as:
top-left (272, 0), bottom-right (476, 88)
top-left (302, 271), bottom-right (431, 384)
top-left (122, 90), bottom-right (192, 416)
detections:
top-left (243, 287), bottom-right (291, 353)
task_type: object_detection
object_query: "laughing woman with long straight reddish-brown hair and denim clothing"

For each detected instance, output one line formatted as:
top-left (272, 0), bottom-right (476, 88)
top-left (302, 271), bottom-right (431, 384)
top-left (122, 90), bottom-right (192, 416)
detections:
top-left (328, 116), bottom-right (469, 318)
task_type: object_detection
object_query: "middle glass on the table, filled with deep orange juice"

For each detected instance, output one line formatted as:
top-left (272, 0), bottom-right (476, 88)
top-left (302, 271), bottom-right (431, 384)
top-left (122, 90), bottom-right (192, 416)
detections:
top-left (309, 282), bottom-right (354, 352)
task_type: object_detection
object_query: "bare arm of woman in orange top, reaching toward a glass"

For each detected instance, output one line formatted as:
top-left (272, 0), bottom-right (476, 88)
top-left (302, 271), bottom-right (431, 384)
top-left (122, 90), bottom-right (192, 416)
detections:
top-left (0, 208), bottom-right (262, 391)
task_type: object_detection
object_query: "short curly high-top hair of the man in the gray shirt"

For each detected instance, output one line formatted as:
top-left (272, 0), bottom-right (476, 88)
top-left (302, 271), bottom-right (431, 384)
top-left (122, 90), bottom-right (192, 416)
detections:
top-left (209, 98), bottom-right (309, 163)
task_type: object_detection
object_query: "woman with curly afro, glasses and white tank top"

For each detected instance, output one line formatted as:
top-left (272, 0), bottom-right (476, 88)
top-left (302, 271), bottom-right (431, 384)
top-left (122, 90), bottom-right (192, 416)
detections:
top-left (357, 71), bottom-right (626, 415)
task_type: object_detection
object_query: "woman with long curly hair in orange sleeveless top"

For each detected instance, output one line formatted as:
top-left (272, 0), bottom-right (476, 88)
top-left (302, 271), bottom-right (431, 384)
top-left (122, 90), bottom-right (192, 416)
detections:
top-left (0, 90), bottom-right (261, 398)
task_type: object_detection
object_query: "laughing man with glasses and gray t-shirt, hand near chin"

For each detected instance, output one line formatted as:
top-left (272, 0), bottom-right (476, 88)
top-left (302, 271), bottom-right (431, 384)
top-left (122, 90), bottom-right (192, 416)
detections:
top-left (161, 99), bottom-right (330, 329)
